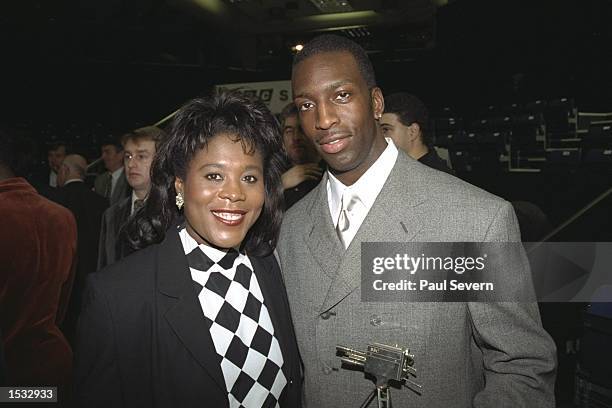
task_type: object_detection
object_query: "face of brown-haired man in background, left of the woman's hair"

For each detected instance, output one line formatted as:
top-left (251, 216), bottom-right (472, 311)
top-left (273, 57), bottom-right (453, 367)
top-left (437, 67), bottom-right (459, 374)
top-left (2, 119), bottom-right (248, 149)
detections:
top-left (123, 139), bottom-right (155, 192)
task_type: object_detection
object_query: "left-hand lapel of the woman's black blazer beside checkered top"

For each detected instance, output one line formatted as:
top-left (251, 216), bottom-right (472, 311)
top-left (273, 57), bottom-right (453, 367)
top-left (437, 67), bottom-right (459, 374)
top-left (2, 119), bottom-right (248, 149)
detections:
top-left (157, 226), bottom-right (227, 393)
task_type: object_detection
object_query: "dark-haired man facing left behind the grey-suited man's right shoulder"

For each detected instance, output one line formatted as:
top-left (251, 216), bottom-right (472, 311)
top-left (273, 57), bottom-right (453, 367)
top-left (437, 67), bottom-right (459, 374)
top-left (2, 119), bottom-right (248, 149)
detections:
top-left (380, 92), bottom-right (453, 174)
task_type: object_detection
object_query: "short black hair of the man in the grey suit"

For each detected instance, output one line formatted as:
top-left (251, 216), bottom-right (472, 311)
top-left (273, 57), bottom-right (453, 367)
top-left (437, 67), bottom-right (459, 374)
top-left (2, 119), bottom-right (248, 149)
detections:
top-left (293, 34), bottom-right (376, 89)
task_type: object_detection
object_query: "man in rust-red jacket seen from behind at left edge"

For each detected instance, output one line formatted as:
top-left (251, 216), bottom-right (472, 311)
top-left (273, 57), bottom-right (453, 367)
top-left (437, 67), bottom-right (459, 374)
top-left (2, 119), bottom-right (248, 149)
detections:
top-left (0, 133), bottom-right (77, 392)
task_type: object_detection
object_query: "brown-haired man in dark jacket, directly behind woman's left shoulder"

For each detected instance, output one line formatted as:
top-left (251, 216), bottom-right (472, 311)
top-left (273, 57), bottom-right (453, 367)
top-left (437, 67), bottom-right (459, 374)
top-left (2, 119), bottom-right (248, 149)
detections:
top-left (98, 126), bottom-right (165, 269)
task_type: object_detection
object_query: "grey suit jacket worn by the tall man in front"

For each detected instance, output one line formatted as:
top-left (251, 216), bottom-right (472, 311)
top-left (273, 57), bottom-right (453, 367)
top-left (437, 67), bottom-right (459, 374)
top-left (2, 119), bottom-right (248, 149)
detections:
top-left (278, 151), bottom-right (556, 408)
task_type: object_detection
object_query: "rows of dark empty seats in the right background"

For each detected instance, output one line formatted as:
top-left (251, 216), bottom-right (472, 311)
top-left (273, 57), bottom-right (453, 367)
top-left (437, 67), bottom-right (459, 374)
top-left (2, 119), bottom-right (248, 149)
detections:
top-left (434, 98), bottom-right (612, 173)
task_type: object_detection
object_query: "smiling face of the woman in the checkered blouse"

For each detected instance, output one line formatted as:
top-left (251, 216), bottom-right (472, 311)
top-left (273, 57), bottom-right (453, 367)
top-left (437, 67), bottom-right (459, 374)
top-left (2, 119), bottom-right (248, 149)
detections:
top-left (175, 133), bottom-right (265, 248)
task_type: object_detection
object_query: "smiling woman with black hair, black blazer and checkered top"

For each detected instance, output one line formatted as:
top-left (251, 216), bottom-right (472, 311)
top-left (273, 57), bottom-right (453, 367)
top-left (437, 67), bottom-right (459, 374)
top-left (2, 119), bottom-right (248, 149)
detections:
top-left (75, 94), bottom-right (301, 407)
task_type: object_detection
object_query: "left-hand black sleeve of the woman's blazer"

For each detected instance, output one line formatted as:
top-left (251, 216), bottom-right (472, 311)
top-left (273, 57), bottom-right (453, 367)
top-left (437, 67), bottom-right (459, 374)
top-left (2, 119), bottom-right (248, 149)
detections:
top-left (74, 274), bottom-right (123, 408)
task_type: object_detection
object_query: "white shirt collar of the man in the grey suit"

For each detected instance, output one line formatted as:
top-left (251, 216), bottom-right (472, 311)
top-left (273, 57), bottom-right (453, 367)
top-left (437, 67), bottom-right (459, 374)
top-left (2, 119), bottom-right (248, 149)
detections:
top-left (327, 137), bottom-right (398, 222)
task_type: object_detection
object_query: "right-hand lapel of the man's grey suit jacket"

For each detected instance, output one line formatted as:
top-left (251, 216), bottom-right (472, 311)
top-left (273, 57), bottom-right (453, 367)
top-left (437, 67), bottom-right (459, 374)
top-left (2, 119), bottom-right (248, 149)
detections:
top-left (321, 151), bottom-right (427, 312)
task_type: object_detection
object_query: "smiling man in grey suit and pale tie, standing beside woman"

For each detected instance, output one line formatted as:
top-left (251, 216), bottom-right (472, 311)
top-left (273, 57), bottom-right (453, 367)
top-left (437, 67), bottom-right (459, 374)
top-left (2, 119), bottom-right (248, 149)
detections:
top-left (278, 35), bottom-right (555, 408)
